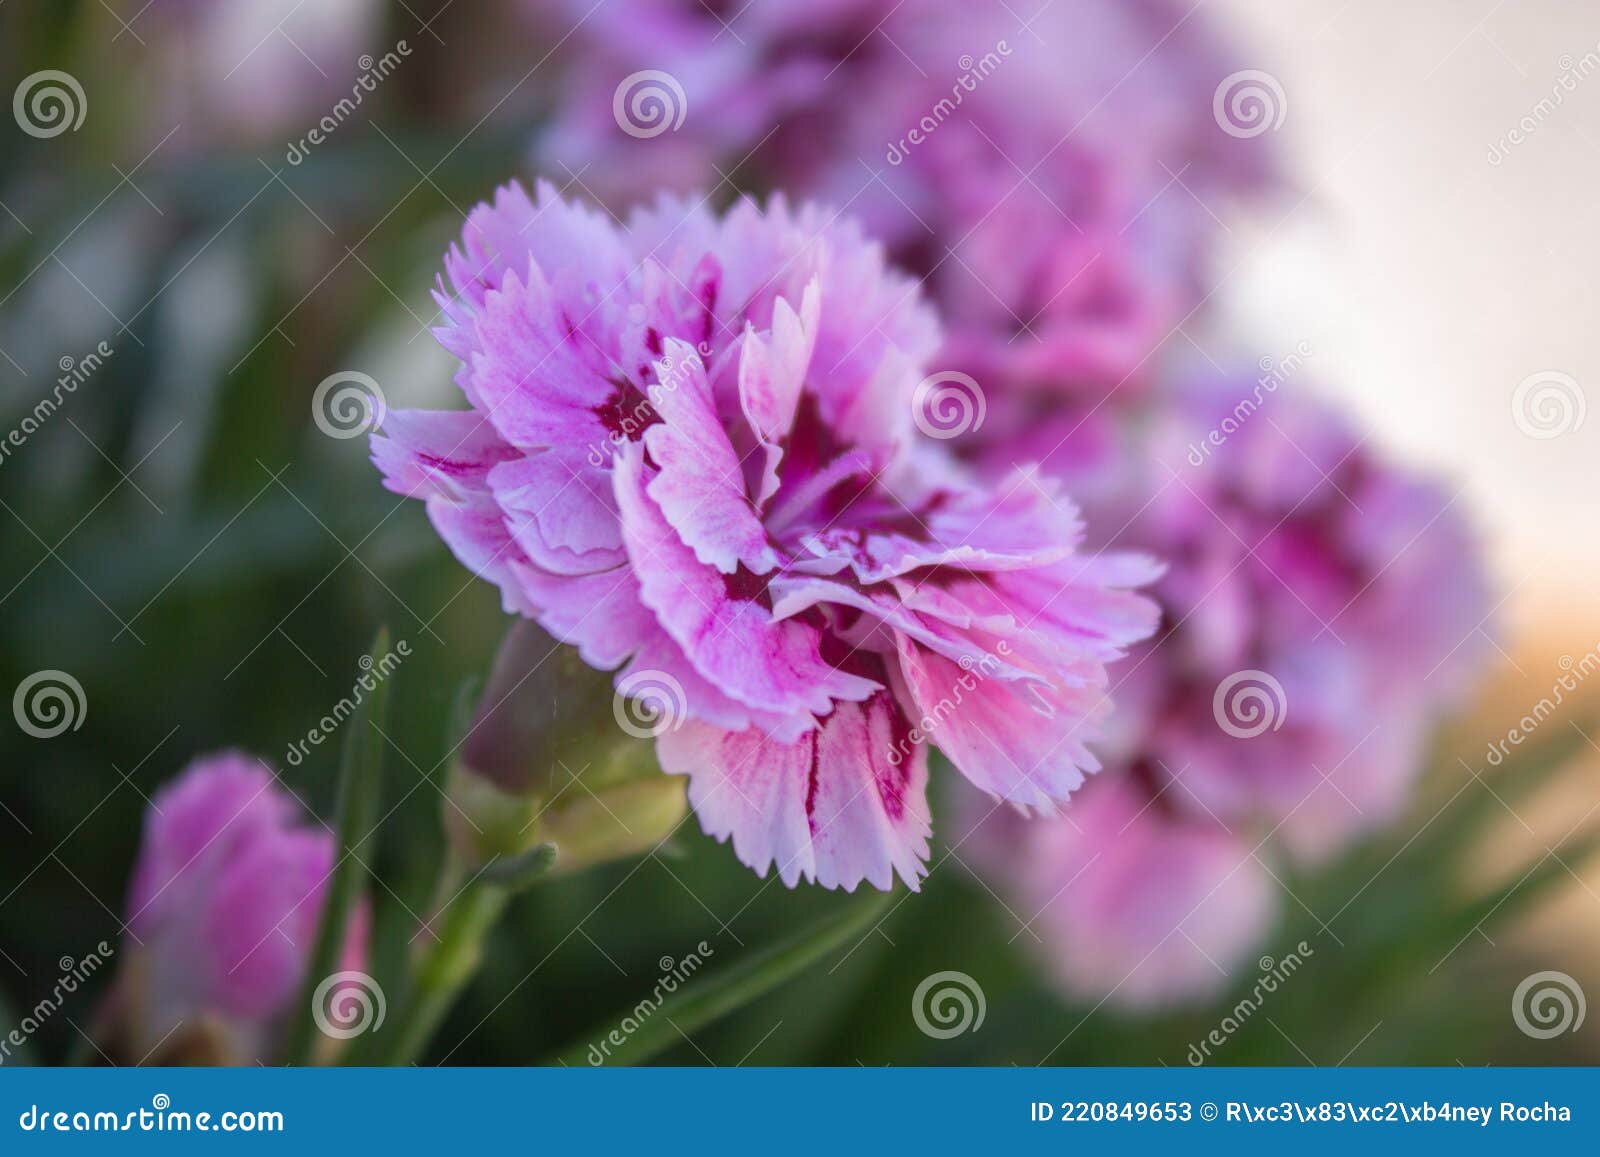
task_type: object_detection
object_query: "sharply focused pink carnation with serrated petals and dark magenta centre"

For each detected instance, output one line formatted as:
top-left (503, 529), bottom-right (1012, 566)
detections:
top-left (373, 186), bottom-right (1155, 888)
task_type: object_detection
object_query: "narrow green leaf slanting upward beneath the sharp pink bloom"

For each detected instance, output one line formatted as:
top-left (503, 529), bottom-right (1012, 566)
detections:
top-left (554, 891), bottom-right (893, 1066)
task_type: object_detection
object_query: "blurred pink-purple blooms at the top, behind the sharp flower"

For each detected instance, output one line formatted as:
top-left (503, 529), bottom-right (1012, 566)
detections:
top-left (530, 0), bottom-right (1277, 395)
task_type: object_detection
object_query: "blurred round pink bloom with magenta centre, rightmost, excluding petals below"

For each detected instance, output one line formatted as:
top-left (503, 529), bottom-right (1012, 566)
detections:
top-left (1093, 378), bottom-right (1490, 859)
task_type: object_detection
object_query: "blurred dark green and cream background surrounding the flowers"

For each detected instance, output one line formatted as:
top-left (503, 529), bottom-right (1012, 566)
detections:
top-left (0, 0), bottom-right (1600, 1064)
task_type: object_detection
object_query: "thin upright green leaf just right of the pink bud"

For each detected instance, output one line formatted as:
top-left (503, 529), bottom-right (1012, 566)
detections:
top-left (283, 627), bottom-right (394, 1064)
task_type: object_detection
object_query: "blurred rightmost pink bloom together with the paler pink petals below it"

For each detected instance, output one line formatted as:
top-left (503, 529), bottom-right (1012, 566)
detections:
top-left (953, 376), bottom-right (1488, 1003)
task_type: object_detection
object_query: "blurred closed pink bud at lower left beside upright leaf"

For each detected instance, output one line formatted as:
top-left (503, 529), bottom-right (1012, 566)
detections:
top-left (107, 752), bottom-right (365, 1064)
